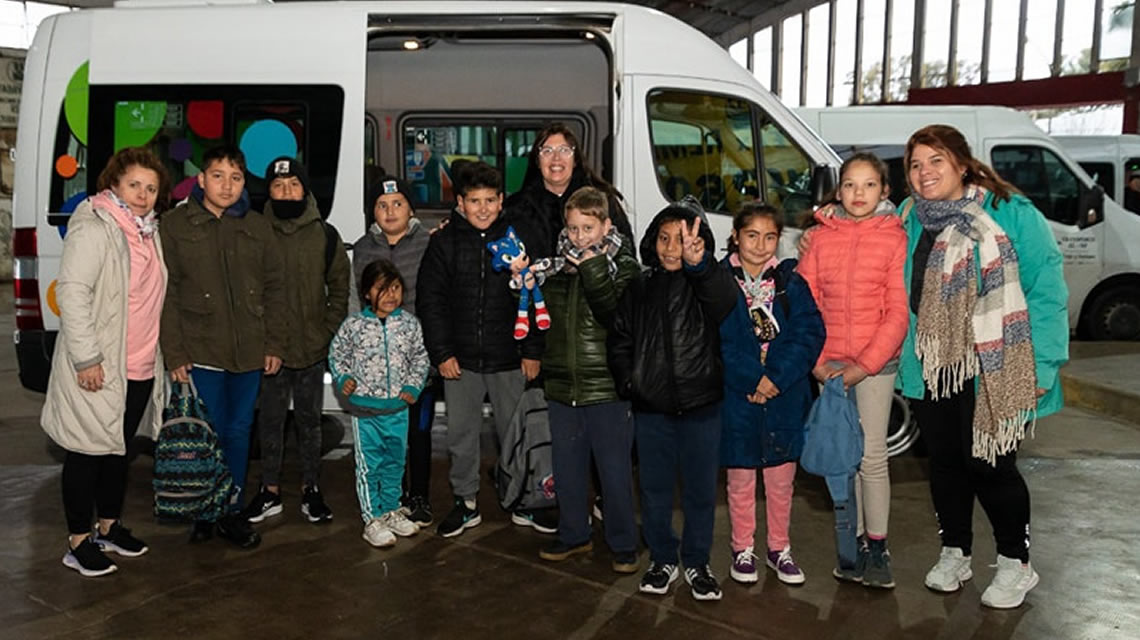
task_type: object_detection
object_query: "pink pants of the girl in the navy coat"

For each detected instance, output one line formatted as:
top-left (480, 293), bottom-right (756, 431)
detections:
top-left (727, 462), bottom-right (796, 551)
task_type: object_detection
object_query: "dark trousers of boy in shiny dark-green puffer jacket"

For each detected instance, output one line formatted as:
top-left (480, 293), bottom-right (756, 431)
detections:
top-left (547, 400), bottom-right (638, 553)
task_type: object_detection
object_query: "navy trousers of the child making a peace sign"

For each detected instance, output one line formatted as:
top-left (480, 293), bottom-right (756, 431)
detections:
top-left (633, 403), bottom-right (720, 568)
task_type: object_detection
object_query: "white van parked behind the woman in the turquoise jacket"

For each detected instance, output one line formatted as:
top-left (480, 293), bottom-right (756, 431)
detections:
top-left (797, 106), bottom-right (1140, 340)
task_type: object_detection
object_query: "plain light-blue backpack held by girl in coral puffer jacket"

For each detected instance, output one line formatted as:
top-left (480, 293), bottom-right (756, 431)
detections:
top-left (799, 376), bottom-right (863, 569)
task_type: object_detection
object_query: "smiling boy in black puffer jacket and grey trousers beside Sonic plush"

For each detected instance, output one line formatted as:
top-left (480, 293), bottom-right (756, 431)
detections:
top-left (416, 162), bottom-right (556, 537)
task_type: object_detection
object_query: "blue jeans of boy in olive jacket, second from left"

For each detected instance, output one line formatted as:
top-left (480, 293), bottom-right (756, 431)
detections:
top-left (190, 366), bottom-right (261, 512)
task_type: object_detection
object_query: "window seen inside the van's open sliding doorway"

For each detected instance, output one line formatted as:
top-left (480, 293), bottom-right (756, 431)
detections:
top-left (397, 114), bottom-right (596, 209)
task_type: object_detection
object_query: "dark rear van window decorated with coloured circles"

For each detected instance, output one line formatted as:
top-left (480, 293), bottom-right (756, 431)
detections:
top-left (66, 84), bottom-right (342, 223)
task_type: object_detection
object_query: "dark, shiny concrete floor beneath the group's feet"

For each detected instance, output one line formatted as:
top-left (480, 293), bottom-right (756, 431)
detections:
top-left (0, 292), bottom-right (1140, 640)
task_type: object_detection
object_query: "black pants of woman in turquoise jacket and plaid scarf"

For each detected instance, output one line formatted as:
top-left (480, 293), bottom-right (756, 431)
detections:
top-left (911, 380), bottom-right (1029, 562)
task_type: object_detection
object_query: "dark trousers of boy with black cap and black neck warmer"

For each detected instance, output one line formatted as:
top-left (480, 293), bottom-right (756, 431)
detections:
top-left (258, 360), bottom-right (325, 487)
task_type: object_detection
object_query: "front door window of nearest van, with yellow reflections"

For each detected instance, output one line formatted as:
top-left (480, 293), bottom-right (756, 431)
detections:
top-left (648, 89), bottom-right (760, 213)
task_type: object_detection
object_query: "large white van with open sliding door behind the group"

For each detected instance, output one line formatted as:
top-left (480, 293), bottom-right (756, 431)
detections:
top-left (14, 0), bottom-right (838, 394)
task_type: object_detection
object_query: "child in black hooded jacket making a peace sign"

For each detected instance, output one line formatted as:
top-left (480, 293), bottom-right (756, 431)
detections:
top-left (608, 196), bottom-right (740, 600)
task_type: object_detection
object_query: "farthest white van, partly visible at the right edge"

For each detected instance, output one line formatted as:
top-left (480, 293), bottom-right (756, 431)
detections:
top-left (1053, 133), bottom-right (1140, 214)
